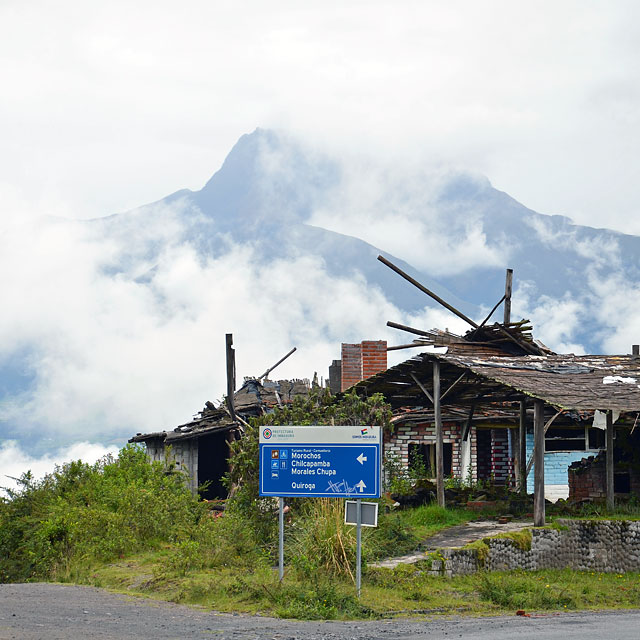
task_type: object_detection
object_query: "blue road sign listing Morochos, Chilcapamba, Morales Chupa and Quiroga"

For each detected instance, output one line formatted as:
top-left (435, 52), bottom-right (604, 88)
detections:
top-left (260, 426), bottom-right (381, 498)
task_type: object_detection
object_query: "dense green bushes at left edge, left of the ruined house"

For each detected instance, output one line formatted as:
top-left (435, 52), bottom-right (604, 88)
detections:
top-left (0, 445), bottom-right (205, 582)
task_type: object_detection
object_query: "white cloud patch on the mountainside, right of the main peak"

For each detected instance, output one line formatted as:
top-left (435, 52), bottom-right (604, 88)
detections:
top-left (309, 160), bottom-right (509, 277)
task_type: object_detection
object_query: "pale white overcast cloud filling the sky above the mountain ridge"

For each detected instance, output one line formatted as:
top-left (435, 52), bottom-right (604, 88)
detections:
top-left (0, 0), bottom-right (640, 232)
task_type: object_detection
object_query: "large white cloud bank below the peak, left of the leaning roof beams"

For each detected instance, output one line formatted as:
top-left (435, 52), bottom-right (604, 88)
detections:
top-left (0, 201), bottom-right (430, 454)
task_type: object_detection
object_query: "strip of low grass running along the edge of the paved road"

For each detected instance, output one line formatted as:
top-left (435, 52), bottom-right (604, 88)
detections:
top-left (63, 549), bottom-right (640, 620)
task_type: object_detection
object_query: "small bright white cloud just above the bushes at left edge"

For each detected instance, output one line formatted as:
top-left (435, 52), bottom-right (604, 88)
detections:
top-left (0, 441), bottom-right (118, 496)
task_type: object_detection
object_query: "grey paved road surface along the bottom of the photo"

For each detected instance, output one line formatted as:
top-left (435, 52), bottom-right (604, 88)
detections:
top-left (0, 584), bottom-right (640, 640)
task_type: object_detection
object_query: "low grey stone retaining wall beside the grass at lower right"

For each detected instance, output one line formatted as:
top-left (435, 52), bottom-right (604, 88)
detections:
top-left (430, 520), bottom-right (640, 576)
